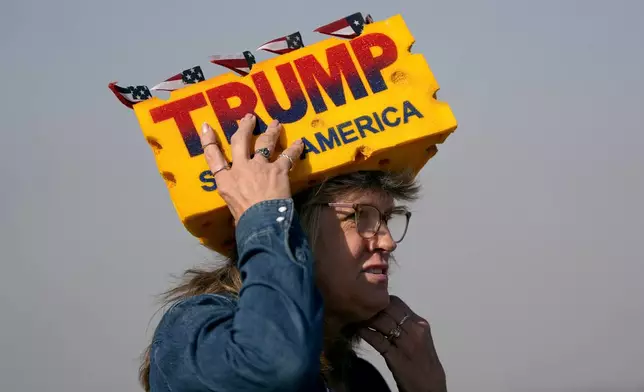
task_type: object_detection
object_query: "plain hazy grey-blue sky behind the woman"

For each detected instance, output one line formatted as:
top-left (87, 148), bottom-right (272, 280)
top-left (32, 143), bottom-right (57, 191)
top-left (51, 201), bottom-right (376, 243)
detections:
top-left (0, 0), bottom-right (644, 392)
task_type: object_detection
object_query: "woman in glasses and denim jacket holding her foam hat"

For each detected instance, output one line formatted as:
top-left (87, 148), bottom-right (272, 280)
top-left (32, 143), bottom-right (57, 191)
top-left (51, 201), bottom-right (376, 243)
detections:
top-left (140, 114), bottom-right (446, 392)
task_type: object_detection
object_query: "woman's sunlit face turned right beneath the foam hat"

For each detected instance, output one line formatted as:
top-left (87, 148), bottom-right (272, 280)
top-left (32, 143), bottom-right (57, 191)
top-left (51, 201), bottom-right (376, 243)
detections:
top-left (315, 191), bottom-right (396, 323)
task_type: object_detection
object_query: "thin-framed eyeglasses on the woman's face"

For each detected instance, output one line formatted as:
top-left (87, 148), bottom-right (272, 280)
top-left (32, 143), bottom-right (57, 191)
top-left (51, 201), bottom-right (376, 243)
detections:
top-left (326, 203), bottom-right (411, 243)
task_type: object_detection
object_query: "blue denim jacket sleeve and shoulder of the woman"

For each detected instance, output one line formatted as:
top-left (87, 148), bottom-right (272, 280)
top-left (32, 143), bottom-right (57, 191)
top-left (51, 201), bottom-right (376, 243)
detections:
top-left (150, 199), bottom-right (324, 392)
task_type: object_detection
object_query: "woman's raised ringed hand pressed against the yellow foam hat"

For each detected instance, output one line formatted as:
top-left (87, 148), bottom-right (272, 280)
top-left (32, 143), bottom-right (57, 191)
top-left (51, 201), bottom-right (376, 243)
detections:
top-left (201, 114), bottom-right (304, 222)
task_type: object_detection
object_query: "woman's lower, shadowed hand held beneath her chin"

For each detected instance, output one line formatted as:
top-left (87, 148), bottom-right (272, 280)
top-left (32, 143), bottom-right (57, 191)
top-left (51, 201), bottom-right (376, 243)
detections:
top-left (360, 296), bottom-right (447, 392)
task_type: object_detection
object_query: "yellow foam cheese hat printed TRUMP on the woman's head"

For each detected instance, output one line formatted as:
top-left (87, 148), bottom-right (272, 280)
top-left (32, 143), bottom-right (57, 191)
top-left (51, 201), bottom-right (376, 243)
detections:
top-left (134, 15), bottom-right (457, 254)
